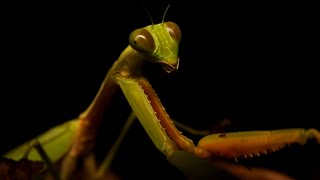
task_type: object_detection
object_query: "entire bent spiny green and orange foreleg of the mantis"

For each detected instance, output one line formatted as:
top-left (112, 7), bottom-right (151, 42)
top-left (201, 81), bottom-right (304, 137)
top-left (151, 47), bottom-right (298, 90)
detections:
top-left (118, 71), bottom-right (320, 162)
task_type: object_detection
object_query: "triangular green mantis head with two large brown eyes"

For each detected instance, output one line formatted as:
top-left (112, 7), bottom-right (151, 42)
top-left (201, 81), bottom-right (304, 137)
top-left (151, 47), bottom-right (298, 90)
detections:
top-left (129, 22), bottom-right (181, 73)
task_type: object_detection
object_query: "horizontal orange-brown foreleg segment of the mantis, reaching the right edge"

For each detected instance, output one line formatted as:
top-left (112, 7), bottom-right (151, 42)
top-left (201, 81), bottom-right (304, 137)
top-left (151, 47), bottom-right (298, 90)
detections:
top-left (198, 128), bottom-right (320, 158)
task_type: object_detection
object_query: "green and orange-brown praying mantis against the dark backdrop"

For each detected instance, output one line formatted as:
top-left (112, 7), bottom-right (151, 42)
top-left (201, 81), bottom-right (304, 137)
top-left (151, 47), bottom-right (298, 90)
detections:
top-left (5, 8), bottom-right (320, 179)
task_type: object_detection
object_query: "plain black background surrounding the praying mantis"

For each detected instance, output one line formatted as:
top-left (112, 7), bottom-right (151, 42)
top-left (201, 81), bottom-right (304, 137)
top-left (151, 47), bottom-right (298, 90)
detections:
top-left (0, 0), bottom-right (320, 177)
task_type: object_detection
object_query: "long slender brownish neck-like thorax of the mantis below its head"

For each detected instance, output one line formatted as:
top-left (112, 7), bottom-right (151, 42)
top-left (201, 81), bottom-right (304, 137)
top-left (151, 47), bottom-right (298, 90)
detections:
top-left (66, 46), bottom-right (148, 162)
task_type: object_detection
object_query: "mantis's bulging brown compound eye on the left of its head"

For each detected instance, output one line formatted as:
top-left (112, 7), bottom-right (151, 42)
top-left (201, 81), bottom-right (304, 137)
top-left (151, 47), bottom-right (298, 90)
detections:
top-left (129, 29), bottom-right (156, 53)
